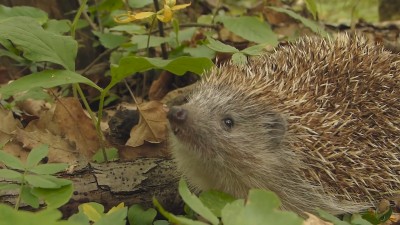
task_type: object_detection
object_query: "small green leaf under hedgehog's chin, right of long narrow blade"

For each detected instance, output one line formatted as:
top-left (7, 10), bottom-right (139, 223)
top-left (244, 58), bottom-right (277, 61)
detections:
top-left (199, 190), bottom-right (235, 217)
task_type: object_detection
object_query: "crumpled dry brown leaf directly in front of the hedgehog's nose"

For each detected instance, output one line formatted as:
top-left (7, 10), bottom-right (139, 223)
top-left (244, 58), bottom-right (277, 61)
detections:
top-left (126, 101), bottom-right (167, 147)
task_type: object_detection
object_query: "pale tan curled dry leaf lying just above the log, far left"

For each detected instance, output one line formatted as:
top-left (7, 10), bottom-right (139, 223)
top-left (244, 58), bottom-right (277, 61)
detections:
top-left (15, 129), bottom-right (79, 163)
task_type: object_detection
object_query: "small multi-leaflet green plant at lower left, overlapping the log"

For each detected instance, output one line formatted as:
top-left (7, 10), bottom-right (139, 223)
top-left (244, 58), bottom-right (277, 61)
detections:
top-left (0, 145), bottom-right (73, 209)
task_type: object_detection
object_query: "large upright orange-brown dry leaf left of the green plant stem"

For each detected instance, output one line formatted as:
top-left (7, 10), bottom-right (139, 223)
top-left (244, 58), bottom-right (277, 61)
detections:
top-left (53, 98), bottom-right (100, 158)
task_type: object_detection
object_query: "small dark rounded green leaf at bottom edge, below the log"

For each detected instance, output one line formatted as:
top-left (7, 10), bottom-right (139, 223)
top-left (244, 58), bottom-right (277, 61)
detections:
top-left (128, 205), bottom-right (157, 225)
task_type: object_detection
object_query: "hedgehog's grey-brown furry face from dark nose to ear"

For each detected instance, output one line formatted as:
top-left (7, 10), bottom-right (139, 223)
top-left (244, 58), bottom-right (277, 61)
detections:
top-left (168, 84), bottom-right (286, 163)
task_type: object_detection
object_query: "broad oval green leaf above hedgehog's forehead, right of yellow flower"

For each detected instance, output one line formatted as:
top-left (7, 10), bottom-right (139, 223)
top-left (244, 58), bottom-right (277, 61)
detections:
top-left (215, 16), bottom-right (278, 46)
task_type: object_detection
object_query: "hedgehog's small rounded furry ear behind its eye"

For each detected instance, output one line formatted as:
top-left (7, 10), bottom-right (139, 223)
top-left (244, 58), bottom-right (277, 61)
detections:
top-left (264, 113), bottom-right (287, 144)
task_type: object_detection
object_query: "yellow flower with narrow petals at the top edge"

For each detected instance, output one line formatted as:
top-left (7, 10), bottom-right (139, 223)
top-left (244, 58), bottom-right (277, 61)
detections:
top-left (114, 0), bottom-right (191, 23)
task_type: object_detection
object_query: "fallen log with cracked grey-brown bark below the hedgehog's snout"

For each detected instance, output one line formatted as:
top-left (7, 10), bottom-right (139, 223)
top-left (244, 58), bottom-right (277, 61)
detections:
top-left (0, 158), bottom-right (180, 217)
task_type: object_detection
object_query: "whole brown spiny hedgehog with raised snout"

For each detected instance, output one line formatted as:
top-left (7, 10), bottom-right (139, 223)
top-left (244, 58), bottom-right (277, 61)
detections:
top-left (167, 34), bottom-right (400, 215)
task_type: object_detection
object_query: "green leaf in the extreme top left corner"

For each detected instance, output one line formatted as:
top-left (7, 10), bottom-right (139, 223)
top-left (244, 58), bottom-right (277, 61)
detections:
top-left (0, 5), bottom-right (48, 24)
